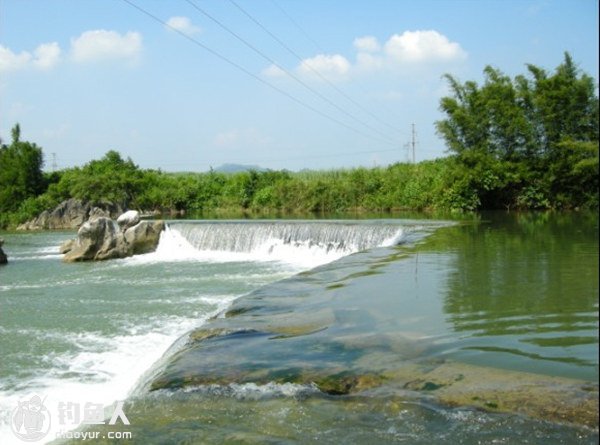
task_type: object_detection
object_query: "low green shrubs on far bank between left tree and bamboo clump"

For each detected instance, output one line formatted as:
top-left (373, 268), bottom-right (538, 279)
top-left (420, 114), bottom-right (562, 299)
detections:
top-left (0, 151), bottom-right (454, 226)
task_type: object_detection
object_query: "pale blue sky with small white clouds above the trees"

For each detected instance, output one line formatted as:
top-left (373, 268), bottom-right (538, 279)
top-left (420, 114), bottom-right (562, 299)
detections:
top-left (0, 0), bottom-right (598, 171)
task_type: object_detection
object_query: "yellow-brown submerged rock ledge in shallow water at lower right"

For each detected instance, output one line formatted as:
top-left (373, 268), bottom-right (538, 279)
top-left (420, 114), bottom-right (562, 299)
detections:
top-left (385, 361), bottom-right (598, 428)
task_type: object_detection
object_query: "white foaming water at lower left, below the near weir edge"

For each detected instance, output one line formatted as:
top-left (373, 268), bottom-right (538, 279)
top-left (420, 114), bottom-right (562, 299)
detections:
top-left (0, 296), bottom-right (235, 445)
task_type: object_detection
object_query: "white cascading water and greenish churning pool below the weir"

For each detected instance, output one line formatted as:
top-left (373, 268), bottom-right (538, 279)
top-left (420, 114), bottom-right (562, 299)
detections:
top-left (0, 221), bottom-right (412, 443)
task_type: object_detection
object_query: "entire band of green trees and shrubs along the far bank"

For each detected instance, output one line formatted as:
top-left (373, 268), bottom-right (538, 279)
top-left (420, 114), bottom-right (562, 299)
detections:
top-left (0, 54), bottom-right (598, 227)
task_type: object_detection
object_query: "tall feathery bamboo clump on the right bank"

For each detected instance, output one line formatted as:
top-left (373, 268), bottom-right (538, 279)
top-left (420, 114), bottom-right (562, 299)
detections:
top-left (436, 54), bottom-right (598, 208)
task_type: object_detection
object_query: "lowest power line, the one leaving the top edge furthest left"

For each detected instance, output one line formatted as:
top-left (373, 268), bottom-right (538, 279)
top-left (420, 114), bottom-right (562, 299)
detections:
top-left (122, 0), bottom-right (393, 144)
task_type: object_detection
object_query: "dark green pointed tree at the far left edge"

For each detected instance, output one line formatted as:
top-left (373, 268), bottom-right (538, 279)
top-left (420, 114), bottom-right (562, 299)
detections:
top-left (0, 124), bottom-right (44, 212)
